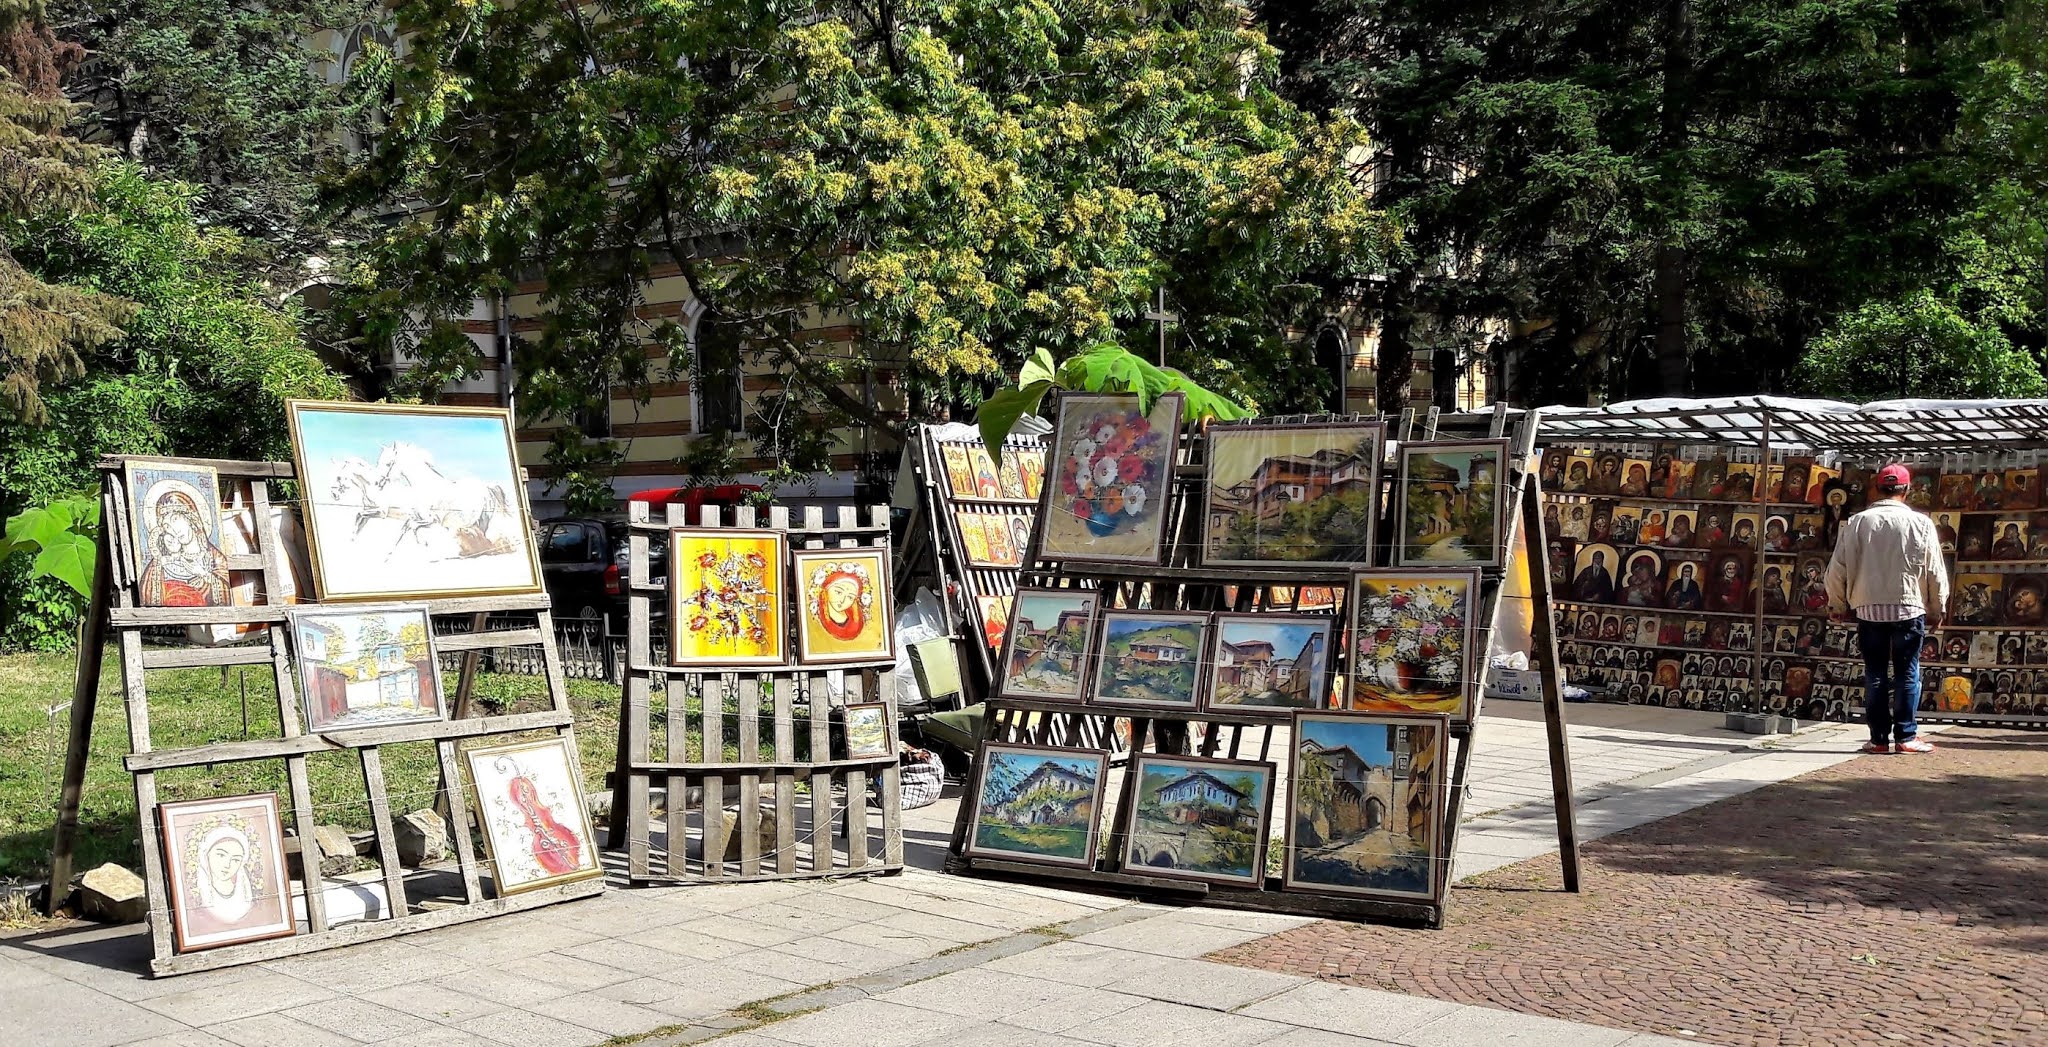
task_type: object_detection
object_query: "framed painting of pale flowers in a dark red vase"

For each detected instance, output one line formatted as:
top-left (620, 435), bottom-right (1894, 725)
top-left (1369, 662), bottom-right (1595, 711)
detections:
top-left (1354, 582), bottom-right (1464, 695)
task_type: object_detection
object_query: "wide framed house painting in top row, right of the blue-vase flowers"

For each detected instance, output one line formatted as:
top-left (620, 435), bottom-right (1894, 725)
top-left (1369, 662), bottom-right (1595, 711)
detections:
top-left (1202, 422), bottom-right (1386, 566)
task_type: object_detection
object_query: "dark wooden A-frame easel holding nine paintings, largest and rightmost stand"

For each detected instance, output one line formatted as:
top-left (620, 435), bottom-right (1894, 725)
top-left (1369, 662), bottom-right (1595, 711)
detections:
top-left (946, 410), bottom-right (1579, 926)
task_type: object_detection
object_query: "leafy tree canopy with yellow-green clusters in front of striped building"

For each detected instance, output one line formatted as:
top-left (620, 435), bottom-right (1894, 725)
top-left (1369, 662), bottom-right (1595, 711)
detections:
top-left (346, 0), bottom-right (1395, 504)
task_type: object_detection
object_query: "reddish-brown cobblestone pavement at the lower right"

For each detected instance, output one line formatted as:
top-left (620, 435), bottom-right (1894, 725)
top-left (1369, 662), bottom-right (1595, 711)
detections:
top-left (1210, 729), bottom-right (2048, 1045)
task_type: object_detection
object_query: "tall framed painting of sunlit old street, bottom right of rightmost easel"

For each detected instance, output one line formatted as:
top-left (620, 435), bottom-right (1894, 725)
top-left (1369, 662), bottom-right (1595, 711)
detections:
top-left (1280, 713), bottom-right (1450, 902)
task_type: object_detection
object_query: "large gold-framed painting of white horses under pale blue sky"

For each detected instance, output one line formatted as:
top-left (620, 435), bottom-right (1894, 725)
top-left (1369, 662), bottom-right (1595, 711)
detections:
top-left (285, 400), bottom-right (541, 600)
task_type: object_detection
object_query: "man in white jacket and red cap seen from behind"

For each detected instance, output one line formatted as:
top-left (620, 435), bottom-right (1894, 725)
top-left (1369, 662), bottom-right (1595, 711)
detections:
top-left (1827, 465), bottom-right (1948, 752)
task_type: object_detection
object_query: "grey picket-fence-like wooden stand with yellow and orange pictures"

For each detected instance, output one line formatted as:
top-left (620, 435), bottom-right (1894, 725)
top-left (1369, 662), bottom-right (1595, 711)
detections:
top-left (608, 502), bottom-right (907, 885)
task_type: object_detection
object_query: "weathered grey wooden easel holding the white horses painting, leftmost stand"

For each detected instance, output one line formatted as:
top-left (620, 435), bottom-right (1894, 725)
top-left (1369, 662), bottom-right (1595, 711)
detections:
top-left (49, 455), bottom-right (604, 975)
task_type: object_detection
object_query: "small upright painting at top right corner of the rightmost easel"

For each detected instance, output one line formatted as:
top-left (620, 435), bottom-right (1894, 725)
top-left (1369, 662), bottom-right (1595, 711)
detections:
top-left (1395, 441), bottom-right (1507, 568)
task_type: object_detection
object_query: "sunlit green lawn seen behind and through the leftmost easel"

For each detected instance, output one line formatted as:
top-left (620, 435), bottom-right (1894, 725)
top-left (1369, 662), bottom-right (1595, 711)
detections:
top-left (0, 647), bottom-right (622, 879)
